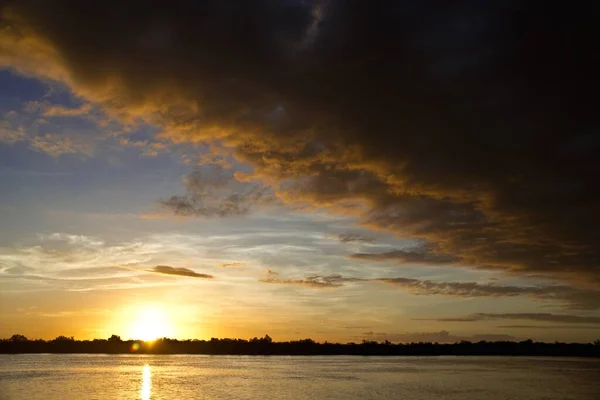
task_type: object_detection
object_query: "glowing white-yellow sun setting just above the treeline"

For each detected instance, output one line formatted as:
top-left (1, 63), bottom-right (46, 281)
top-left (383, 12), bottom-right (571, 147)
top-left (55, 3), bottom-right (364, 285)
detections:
top-left (129, 306), bottom-right (173, 341)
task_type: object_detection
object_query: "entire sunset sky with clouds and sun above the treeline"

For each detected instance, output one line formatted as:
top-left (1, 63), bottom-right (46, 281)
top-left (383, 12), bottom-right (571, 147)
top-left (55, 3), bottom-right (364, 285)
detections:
top-left (0, 0), bottom-right (600, 342)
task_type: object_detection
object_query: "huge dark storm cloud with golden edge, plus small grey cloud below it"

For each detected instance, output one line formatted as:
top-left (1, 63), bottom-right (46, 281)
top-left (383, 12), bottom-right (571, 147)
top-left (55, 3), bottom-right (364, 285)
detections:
top-left (0, 0), bottom-right (600, 285)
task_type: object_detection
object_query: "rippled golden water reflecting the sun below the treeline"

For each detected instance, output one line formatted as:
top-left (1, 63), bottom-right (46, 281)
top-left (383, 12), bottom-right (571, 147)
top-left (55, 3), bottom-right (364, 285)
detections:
top-left (0, 354), bottom-right (600, 400)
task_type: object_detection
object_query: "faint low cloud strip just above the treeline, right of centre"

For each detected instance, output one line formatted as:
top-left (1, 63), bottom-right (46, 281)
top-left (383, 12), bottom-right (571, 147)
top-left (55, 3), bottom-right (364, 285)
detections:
top-left (363, 331), bottom-right (518, 343)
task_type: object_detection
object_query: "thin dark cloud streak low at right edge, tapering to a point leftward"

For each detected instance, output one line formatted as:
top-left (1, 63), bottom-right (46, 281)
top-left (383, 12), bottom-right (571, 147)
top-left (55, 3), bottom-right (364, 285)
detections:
top-left (415, 313), bottom-right (600, 324)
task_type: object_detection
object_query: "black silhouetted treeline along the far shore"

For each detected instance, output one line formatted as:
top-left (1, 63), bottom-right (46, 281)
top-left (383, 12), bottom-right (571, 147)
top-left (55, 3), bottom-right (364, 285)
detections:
top-left (0, 335), bottom-right (600, 357)
